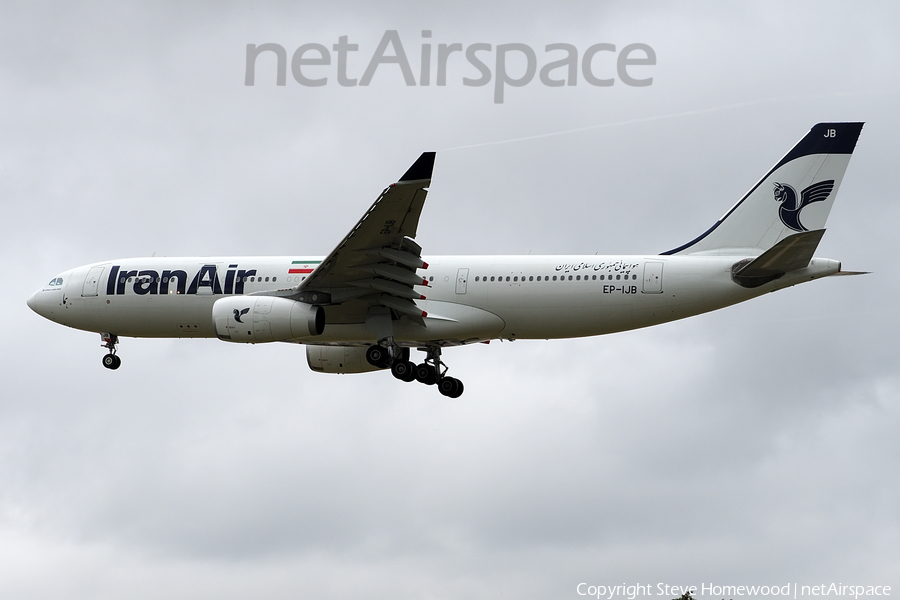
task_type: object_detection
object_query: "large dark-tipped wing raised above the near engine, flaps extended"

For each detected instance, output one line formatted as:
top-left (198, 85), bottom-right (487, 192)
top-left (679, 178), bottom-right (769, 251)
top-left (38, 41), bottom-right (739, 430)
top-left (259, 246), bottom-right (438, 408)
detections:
top-left (294, 152), bottom-right (435, 322)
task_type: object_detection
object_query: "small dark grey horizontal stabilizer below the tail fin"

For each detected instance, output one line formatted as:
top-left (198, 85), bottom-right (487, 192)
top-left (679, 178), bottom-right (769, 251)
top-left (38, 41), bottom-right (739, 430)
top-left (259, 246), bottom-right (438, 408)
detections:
top-left (731, 229), bottom-right (825, 288)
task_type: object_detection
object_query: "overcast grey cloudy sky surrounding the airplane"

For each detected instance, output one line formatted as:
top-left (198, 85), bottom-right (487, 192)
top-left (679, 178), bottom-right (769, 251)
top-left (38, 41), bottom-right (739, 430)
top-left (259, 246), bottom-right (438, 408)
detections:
top-left (0, 1), bottom-right (900, 599)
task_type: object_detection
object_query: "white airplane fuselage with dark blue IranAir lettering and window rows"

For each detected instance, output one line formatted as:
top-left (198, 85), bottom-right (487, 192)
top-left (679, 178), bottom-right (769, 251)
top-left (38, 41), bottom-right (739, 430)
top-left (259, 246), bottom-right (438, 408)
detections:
top-left (28, 255), bottom-right (840, 345)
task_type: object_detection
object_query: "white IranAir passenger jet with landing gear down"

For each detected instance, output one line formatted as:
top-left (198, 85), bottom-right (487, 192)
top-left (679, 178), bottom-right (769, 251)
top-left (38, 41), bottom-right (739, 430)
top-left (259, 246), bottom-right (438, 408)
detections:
top-left (28, 123), bottom-right (863, 398)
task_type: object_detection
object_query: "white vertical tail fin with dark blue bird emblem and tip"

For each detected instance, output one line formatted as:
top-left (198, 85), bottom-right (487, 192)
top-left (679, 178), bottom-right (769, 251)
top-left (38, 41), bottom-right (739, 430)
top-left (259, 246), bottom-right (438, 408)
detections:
top-left (663, 123), bottom-right (863, 255)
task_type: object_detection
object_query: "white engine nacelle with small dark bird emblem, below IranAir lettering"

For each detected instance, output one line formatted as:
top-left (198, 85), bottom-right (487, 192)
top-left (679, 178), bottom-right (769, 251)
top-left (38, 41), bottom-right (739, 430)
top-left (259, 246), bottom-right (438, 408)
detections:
top-left (213, 296), bottom-right (325, 344)
